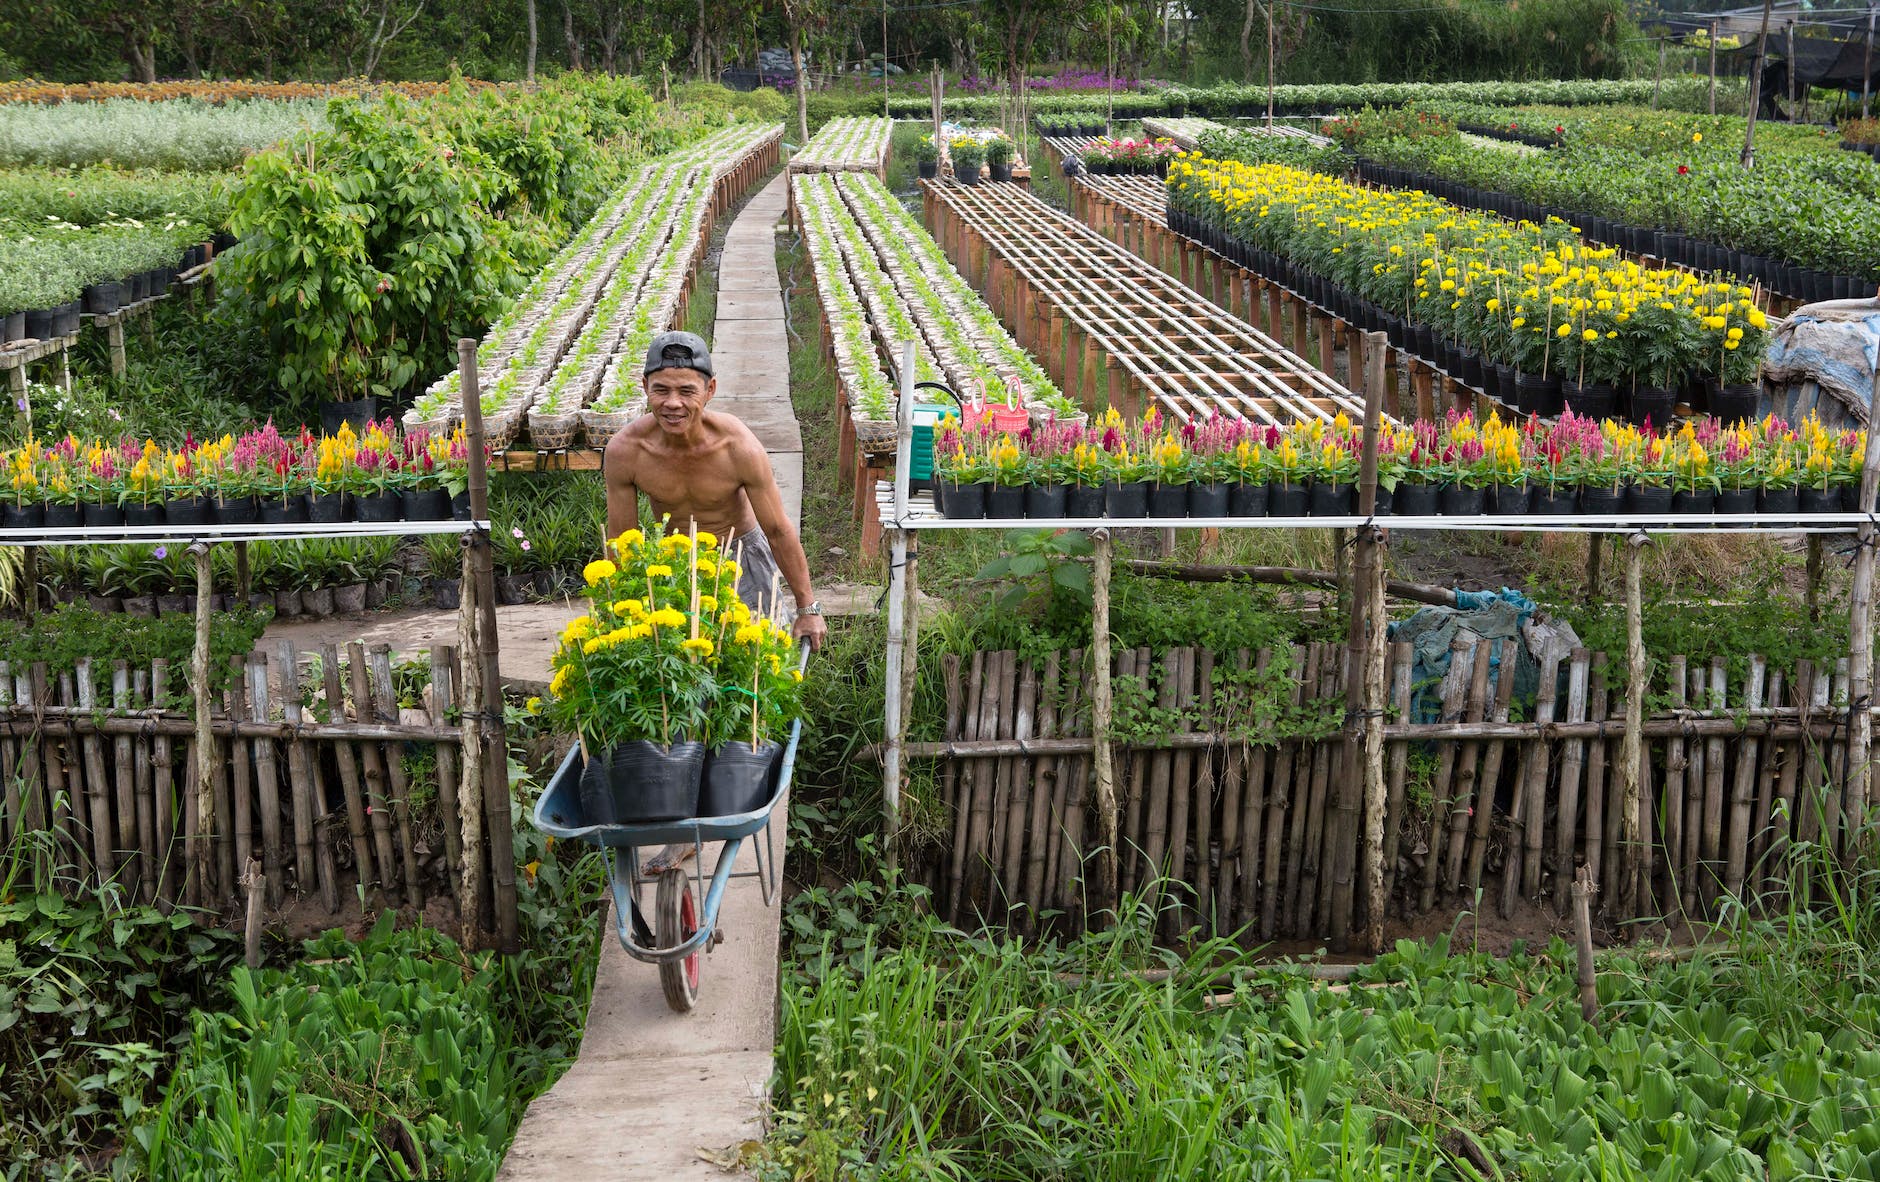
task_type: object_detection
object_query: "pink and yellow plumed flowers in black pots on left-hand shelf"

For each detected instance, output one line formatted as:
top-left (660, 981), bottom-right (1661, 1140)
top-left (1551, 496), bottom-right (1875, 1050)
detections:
top-left (0, 419), bottom-right (468, 530)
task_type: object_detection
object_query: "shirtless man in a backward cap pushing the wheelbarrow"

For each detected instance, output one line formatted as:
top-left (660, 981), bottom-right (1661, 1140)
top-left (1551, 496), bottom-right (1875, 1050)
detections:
top-left (602, 333), bottom-right (825, 648)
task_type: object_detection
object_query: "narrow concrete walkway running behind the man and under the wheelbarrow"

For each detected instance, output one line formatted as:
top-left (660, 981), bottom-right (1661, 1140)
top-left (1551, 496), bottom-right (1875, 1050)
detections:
top-left (498, 175), bottom-right (803, 1182)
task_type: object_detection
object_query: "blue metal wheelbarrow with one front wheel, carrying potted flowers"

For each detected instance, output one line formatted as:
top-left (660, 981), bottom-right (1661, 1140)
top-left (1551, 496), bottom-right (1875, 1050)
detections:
top-left (534, 706), bottom-right (803, 1013)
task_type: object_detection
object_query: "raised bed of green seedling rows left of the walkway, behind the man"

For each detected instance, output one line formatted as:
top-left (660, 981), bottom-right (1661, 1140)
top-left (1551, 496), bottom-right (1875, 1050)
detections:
top-left (404, 124), bottom-right (782, 451)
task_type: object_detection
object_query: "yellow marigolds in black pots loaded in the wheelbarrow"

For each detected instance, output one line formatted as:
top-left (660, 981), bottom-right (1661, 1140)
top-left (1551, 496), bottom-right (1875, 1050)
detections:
top-left (541, 526), bottom-right (803, 825)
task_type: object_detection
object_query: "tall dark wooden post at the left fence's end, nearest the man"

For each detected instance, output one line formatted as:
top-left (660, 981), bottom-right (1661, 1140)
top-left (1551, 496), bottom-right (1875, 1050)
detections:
top-left (457, 336), bottom-right (523, 953)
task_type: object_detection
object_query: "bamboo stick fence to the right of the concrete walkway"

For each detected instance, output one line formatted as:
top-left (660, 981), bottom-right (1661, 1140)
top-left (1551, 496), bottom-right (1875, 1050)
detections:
top-left (906, 637), bottom-right (1880, 940)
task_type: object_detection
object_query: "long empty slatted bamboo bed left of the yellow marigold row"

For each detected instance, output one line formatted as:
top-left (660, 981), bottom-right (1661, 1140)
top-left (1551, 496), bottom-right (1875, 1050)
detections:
top-left (923, 174), bottom-right (1363, 425)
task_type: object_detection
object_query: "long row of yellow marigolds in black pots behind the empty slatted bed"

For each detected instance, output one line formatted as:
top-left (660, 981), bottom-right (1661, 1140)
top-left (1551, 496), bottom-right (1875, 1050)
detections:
top-left (1167, 154), bottom-right (1769, 421)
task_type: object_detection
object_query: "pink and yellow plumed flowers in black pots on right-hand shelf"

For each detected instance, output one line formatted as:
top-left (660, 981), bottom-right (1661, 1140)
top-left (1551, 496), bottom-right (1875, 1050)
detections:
top-left (934, 410), bottom-right (1867, 521)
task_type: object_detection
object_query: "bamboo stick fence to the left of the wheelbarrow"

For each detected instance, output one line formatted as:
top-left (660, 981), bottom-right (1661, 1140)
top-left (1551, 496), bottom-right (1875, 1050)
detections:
top-left (0, 641), bottom-right (513, 932)
